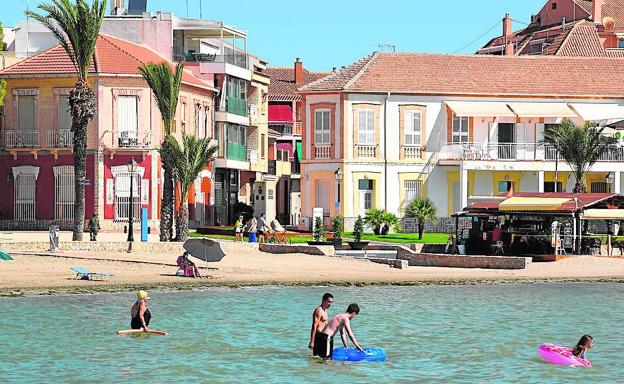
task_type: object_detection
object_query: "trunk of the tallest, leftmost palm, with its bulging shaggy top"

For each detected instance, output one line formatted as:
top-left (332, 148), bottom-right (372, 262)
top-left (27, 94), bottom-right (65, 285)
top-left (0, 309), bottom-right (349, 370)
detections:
top-left (69, 81), bottom-right (96, 241)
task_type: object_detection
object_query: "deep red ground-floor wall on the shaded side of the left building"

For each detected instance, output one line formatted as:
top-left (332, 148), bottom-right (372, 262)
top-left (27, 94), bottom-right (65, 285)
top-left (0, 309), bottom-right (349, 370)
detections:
top-left (0, 154), bottom-right (95, 220)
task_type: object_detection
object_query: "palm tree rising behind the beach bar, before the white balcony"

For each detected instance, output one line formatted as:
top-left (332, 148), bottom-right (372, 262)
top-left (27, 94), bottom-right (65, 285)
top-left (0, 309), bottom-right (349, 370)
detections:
top-left (544, 121), bottom-right (613, 193)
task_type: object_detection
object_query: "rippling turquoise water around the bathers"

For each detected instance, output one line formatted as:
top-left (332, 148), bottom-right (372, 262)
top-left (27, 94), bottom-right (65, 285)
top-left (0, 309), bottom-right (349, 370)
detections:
top-left (0, 284), bottom-right (624, 383)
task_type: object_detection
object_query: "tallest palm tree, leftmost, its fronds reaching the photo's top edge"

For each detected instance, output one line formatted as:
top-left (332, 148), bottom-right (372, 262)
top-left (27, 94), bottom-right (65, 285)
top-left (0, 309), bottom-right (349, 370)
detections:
top-left (26, 0), bottom-right (106, 241)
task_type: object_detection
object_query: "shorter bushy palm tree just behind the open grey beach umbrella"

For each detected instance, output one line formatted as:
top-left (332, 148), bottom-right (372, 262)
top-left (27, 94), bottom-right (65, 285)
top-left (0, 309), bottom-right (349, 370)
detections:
top-left (161, 133), bottom-right (218, 241)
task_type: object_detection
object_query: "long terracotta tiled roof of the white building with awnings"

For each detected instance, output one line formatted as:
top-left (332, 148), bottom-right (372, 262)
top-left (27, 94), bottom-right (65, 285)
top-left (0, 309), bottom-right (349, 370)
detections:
top-left (300, 52), bottom-right (624, 97)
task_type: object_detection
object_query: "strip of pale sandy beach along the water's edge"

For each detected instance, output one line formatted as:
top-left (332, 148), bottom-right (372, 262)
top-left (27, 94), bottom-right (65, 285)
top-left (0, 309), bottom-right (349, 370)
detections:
top-left (0, 242), bottom-right (624, 295)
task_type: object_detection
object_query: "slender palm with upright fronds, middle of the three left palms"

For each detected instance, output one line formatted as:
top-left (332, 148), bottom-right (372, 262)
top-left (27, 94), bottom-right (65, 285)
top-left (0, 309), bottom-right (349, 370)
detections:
top-left (139, 61), bottom-right (183, 241)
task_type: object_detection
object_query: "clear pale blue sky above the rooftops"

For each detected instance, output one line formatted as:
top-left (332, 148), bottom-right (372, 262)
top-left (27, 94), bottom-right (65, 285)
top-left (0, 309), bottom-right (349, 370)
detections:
top-left (0, 0), bottom-right (546, 71)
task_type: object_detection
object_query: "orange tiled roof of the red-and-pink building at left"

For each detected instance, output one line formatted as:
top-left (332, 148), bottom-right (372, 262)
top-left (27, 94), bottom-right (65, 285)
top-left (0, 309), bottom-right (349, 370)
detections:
top-left (0, 35), bottom-right (212, 88)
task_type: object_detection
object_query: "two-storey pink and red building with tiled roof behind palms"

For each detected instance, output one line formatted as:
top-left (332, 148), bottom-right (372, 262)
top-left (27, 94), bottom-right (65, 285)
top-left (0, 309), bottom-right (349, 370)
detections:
top-left (0, 35), bottom-right (214, 229)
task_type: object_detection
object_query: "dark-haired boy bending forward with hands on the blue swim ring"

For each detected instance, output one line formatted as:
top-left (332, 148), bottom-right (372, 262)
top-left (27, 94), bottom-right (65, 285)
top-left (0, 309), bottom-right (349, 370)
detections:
top-left (314, 304), bottom-right (364, 360)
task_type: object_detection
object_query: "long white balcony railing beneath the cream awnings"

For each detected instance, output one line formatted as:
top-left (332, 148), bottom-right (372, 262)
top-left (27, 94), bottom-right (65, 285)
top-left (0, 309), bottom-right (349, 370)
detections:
top-left (439, 143), bottom-right (624, 161)
